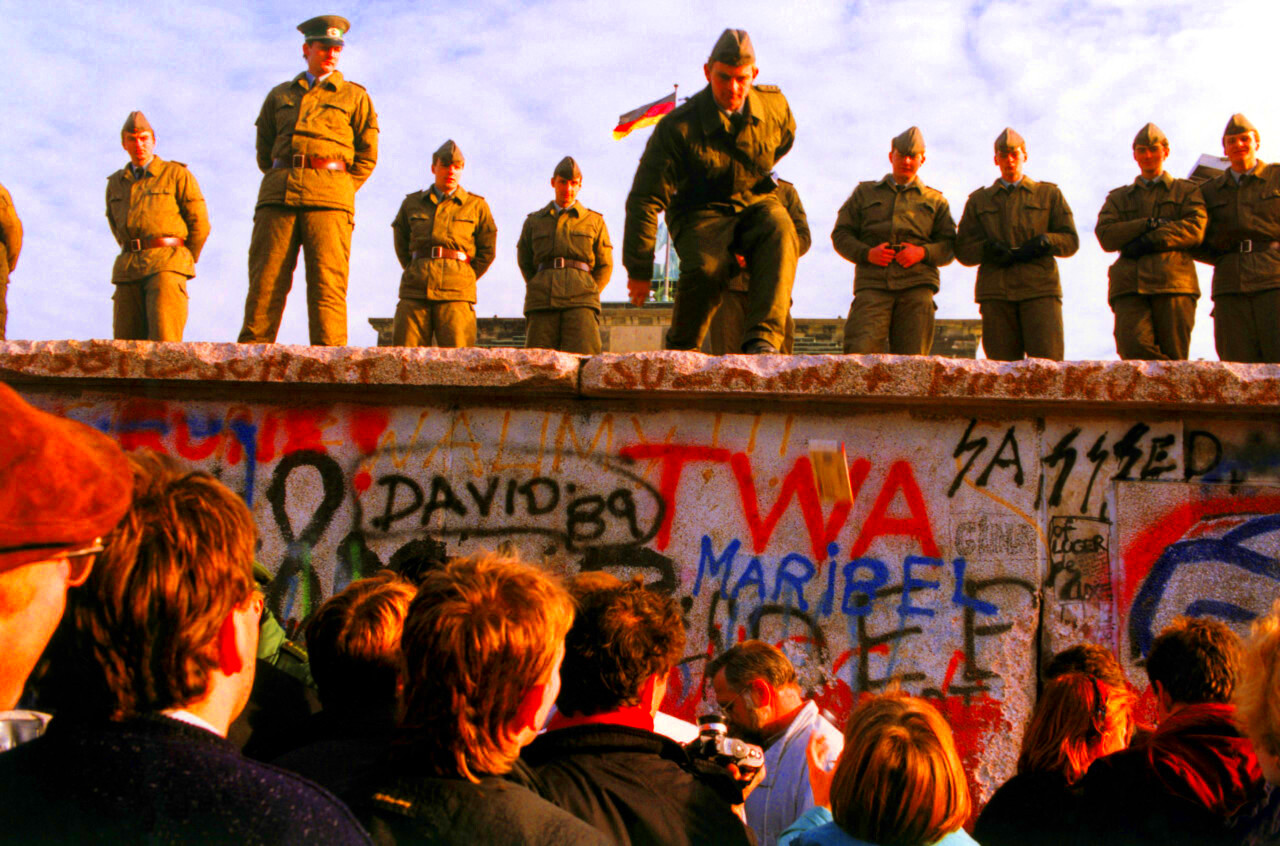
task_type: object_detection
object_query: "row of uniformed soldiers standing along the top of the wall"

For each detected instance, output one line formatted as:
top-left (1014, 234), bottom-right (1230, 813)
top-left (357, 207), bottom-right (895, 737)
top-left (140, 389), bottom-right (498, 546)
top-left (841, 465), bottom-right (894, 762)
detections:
top-left (0, 22), bottom-right (1280, 362)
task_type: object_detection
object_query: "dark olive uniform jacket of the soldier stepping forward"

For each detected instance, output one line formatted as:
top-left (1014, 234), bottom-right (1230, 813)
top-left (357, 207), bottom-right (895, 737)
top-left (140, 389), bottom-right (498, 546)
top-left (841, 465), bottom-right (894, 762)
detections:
top-left (622, 86), bottom-right (796, 279)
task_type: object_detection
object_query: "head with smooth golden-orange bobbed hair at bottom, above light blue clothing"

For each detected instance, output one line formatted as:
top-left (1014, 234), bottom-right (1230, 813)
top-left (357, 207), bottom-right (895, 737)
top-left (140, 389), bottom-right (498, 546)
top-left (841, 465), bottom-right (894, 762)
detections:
top-left (831, 694), bottom-right (970, 846)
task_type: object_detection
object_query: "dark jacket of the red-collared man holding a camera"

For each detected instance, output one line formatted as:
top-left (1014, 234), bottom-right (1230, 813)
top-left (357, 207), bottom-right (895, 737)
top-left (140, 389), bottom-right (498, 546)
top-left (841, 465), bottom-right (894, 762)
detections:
top-left (524, 724), bottom-right (754, 846)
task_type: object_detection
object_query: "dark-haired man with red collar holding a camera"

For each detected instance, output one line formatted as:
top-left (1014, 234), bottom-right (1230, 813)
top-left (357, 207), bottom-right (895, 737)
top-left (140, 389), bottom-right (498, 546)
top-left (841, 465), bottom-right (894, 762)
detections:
top-left (522, 579), bottom-right (763, 846)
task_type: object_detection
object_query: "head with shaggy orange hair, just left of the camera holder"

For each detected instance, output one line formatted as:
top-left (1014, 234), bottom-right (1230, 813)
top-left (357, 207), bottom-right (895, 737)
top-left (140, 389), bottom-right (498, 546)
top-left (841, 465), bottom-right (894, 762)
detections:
top-left (401, 553), bottom-right (573, 779)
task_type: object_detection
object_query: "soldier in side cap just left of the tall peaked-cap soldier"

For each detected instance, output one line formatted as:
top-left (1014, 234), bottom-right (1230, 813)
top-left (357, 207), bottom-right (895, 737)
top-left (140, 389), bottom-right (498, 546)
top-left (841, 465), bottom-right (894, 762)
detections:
top-left (106, 111), bottom-right (209, 340)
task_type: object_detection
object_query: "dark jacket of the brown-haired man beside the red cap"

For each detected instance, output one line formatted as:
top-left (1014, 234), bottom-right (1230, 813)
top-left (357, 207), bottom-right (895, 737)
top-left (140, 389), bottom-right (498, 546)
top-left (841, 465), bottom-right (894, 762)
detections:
top-left (0, 715), bottom-right (369, 845)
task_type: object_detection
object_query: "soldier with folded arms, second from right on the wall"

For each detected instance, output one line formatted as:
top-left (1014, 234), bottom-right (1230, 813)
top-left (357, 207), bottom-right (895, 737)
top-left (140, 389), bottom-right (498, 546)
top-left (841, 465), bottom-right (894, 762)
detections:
top-left (1094, 123), bottom-right (1207, 361)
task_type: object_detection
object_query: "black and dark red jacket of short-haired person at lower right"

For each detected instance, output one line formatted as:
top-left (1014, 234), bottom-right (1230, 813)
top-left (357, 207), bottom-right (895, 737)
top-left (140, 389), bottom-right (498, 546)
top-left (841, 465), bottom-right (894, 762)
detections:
top-left (1080, 704), bottom-right (1263, 846)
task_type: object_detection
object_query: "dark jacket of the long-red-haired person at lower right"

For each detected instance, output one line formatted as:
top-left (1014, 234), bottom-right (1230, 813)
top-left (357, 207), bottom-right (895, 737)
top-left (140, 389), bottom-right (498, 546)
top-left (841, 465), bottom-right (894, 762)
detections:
top-left (973, 773), bottom-right (1080, 846)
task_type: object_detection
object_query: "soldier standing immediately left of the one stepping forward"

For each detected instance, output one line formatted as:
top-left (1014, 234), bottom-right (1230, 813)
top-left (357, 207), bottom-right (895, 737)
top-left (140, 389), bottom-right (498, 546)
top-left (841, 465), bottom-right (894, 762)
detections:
top-left (516, 156), bottom-right (613, 356)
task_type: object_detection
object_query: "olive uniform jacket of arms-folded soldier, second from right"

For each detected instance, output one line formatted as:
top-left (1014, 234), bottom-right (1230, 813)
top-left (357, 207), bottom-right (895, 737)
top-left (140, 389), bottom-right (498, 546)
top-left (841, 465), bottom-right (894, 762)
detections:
top-left (1093, 173), bottom-right (1208, 302)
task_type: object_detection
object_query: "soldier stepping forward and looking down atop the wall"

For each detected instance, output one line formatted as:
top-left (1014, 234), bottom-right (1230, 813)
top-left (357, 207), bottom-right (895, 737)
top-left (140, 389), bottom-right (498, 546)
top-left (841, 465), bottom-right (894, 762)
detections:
top-left (622, 29), bottom-right (797, 353)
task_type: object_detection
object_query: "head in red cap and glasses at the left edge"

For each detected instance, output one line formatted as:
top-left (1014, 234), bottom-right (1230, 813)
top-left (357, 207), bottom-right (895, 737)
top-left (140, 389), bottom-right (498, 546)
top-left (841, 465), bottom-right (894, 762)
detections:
top-left (0, 383), bottom-right (133, 710)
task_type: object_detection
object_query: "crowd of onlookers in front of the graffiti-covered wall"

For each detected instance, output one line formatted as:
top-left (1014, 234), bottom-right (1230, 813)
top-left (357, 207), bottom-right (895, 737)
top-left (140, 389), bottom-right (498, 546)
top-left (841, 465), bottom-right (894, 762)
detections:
top-left (0, 384), bottom-right (1280, 846)
